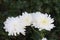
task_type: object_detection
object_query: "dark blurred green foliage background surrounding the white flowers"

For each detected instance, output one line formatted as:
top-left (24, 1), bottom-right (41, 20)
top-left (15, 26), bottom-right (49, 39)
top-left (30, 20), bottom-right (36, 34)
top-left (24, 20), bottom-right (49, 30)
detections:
top-left (0, 0), bottom-right (60, 40)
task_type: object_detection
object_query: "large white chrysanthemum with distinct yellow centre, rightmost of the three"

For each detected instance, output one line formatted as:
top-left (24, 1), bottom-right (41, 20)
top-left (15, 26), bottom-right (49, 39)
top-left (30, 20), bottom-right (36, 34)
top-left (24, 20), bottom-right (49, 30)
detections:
top-left (32, 12), bottom-right (55, 31)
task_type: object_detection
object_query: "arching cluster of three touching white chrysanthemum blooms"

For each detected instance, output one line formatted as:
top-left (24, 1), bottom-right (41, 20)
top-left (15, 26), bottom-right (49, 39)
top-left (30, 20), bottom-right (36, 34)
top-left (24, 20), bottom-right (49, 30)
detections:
top-left (4, 12), bottom-right (55, 36)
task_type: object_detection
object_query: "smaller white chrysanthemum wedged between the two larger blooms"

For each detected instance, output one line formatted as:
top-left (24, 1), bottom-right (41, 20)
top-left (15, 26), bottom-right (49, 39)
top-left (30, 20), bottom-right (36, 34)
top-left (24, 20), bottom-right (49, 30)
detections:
top-left (19, 12), bottom-right (32, 26)
